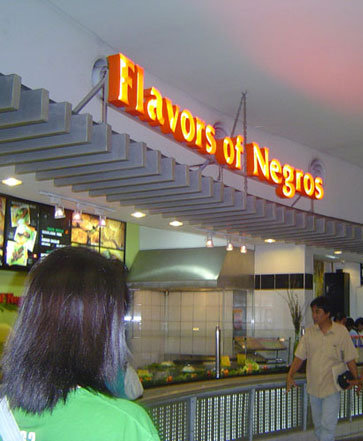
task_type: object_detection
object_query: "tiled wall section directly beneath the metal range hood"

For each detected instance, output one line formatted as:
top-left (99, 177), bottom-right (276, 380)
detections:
top-left (128, 291), bottom-right (233, 367)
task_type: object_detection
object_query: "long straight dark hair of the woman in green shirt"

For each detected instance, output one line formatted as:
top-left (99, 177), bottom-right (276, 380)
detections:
top-left (0, 247), bottom-right (128, 413)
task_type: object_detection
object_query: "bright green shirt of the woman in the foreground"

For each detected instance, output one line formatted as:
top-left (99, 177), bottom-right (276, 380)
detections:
top-left (13, 388), bottom-right (160, 441)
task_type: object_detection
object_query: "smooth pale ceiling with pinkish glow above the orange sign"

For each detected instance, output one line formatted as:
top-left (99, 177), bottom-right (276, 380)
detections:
top-left (50, 0), bottom-right (363, 168)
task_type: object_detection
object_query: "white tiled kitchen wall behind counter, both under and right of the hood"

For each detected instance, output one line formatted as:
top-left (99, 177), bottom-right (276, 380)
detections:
top-left (129, 290), bottom-right (311, 367)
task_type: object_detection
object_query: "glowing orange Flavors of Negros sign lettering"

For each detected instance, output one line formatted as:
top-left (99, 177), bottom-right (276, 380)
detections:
top-left (108, 54), bottom-right (324, 199)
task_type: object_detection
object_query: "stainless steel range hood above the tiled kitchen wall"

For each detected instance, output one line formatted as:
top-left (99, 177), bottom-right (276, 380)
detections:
top-left (128, 247), bottom-right (254, 291)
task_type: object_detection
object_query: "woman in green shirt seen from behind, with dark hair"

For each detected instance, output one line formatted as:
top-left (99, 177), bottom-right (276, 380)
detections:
top-left (0, 247), bottom-right (159, 441)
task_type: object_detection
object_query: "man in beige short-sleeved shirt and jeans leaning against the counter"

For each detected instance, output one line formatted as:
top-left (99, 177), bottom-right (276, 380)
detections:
top-left (286, 296), bottom-right (361, 441)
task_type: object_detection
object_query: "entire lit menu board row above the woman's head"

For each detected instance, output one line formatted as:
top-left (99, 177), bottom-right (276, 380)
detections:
top-left (0, 195), bottom-right (126, 270)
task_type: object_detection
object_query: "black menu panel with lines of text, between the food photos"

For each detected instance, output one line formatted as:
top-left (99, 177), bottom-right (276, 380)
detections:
top-left (39, 205), bottom-right (72, 257)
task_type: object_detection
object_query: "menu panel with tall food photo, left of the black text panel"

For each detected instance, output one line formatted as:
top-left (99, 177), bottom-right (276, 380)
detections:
top-left (4, 199), bottom-right (38, 268)
